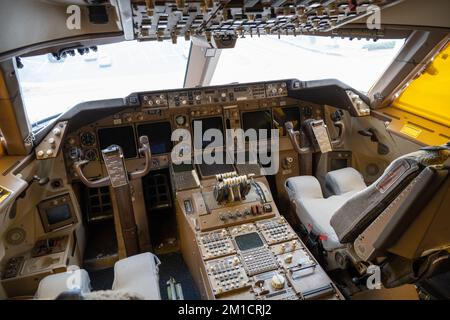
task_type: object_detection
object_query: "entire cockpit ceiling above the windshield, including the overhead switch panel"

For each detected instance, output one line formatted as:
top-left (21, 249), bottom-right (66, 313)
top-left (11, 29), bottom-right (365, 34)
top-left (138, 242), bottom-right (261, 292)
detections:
top-left (0, 0), bottom-right (450, 60)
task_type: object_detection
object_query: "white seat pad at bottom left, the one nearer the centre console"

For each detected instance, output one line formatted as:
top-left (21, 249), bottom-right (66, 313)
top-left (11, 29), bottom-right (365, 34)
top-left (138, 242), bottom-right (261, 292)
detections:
top-left (112, 252), bottom-right (161, 300)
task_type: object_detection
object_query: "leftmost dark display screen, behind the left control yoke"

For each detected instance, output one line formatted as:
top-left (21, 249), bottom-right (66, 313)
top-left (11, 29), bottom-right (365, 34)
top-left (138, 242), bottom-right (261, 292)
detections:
top-left (98, 126), bottom-right (137, 158)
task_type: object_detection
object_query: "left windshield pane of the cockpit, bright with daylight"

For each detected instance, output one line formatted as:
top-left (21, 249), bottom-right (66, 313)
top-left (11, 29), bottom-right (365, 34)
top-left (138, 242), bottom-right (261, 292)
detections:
top-left (19, 41), bottom-right (190, 123)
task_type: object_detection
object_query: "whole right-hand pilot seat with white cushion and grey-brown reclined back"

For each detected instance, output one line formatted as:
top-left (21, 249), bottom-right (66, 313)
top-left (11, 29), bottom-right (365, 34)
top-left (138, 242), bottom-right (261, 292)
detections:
top-left (285, 143), bottom-right (450, 285)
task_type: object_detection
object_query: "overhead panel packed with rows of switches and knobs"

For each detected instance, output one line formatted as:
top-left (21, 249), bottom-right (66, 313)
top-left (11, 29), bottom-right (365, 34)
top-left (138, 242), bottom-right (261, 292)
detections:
top-left (132, 0), bottom-right (399, 41)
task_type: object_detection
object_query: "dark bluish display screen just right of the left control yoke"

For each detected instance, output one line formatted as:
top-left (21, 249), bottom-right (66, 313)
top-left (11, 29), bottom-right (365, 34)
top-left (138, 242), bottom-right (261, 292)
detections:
top-left (137, 122), bottom-right (172, 154)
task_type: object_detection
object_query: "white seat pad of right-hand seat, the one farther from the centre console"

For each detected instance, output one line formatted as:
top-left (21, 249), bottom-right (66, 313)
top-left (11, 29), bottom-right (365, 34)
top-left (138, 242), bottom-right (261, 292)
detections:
top-left (325, 167), bottom-right (367, 195)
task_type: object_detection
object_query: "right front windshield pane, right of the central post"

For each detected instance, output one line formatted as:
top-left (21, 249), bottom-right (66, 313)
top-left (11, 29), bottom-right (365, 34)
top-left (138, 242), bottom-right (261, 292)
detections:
top-left (212, 35), bottom-right (404, 92)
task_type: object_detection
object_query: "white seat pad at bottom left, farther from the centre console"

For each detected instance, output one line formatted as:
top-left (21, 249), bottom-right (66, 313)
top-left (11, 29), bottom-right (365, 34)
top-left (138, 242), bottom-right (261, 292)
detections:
top-left (35, 266), bottom-right (91, 300)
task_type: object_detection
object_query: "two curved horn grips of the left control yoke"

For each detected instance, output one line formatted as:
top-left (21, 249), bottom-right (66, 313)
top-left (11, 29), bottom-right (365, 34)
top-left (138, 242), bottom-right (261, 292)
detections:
top-left (73, 136), bottom-right (152, 188)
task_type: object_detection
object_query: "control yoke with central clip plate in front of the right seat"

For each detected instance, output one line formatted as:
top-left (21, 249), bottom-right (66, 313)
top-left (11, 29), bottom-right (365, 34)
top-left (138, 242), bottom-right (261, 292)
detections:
top-left (285, 110), bottom-right (345, 154)
